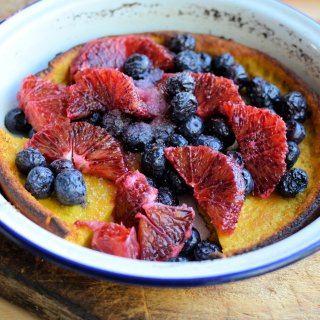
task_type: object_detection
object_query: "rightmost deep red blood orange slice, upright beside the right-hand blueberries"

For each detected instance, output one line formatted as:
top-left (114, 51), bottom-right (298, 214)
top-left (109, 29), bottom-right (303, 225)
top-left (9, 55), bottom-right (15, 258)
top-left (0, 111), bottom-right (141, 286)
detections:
top-left (224, 103), bottom-right (288, 198)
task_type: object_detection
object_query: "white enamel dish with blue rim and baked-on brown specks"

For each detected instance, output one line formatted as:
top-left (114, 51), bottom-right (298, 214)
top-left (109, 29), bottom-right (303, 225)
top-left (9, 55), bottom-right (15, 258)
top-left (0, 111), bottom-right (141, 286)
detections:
top-left (0, 0), bottom-right (320, 287)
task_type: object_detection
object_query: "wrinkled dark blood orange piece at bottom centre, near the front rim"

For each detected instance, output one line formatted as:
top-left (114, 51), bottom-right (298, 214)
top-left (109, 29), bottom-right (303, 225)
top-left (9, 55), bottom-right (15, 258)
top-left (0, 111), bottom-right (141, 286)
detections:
top-left (136, 203), bottom-right (195, 261)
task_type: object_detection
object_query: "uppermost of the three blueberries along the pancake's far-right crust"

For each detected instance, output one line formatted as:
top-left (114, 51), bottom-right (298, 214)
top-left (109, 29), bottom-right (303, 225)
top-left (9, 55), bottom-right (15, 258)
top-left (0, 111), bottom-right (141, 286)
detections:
top-left (278, 91), bottom-right (307, 122)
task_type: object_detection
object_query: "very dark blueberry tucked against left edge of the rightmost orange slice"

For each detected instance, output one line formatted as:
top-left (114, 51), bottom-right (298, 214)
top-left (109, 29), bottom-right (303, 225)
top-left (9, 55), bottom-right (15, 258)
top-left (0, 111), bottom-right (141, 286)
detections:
top-left (204, 117), bottom-right (235, 147)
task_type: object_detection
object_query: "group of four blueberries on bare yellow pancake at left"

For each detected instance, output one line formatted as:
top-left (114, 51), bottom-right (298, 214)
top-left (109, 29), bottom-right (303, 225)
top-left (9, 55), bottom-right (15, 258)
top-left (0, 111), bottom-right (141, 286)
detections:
top-left (16, 147), bottom-right (87, 205)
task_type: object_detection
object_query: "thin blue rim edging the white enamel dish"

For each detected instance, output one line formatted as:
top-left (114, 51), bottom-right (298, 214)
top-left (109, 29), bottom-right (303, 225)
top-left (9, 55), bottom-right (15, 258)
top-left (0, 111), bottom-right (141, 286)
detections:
top-left (0, 0), bottom-right (320, 288)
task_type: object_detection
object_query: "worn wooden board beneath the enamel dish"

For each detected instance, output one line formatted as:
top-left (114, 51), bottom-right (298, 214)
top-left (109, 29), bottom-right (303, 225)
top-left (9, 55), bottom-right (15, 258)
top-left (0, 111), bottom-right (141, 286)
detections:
top-left (0, 0), bottom-right (320, 320)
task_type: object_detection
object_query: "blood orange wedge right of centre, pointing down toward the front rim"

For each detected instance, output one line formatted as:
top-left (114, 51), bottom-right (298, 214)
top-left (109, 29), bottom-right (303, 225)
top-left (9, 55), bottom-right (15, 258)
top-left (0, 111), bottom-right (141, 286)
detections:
top-left (165, 146), bottom-right (245, 233)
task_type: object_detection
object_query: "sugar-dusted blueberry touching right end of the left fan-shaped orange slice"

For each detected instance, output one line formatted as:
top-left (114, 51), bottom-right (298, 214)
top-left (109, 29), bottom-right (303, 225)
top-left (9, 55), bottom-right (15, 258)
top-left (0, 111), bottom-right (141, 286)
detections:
top-left (122, 122), bottom-right (153, 152)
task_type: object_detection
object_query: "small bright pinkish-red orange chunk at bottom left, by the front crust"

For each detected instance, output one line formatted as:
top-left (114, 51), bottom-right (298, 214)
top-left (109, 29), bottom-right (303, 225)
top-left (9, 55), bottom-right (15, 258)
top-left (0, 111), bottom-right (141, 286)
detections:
top-left (75, 221), bottom-right (140, 259)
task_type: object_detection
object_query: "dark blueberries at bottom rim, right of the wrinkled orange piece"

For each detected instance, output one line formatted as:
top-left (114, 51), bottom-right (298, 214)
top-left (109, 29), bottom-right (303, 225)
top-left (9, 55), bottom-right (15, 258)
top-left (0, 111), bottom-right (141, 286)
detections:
top-left (167, 228), bottom-right (222, 262)
